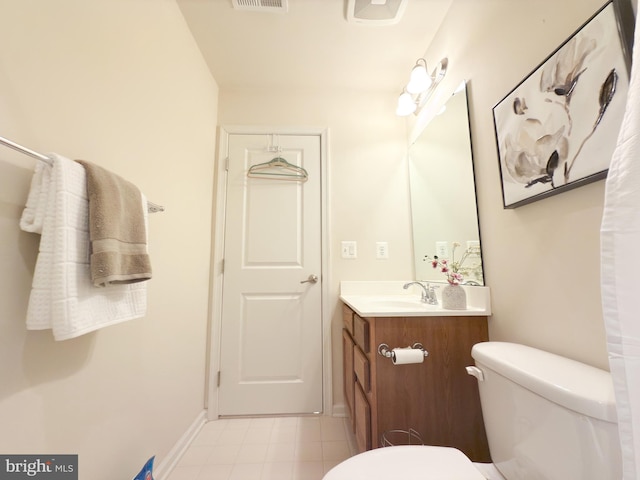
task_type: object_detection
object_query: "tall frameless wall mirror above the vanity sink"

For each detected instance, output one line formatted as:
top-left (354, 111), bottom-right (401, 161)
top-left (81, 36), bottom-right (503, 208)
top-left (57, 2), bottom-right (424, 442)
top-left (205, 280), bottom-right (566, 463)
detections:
top-left (409, 82), bottom-right (484, 285)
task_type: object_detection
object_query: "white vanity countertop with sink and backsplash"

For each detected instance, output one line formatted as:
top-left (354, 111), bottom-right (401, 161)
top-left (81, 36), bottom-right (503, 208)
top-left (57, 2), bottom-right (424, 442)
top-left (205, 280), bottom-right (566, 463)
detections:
top-left (340, 281), bottom-right (491, 317)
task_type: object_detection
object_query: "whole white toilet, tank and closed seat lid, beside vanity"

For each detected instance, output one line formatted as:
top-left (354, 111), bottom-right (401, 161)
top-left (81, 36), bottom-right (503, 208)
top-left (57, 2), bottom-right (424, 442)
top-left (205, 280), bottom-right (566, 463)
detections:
top-left (323, 342), bottom-right (622, 480)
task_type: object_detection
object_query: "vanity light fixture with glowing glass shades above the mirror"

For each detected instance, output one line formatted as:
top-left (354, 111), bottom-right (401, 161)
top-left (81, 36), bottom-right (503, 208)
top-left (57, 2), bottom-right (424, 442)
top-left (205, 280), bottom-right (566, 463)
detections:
top-left (396, 57), bottom-right (449, 117)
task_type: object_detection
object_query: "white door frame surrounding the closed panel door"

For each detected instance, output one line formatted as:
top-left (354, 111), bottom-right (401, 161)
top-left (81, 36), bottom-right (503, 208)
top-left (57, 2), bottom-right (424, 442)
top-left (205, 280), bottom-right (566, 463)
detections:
top-left (204, 125), bottom-right (333, 420)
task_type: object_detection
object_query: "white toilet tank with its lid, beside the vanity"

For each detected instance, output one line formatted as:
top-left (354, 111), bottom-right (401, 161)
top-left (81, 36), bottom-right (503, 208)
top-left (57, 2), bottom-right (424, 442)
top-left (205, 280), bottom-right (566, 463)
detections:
top-left (471, 342), bottom-right (622, 480)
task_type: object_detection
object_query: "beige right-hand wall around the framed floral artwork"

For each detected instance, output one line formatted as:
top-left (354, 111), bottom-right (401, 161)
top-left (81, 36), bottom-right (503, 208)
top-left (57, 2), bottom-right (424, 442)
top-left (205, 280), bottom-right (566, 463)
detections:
top-left (410, 0), bottom-right (624, 369)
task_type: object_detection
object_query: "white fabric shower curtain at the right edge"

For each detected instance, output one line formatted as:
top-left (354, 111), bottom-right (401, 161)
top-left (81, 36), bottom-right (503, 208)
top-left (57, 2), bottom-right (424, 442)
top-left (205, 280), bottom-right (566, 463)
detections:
top-left (600, 7), bottom-right (640, 480)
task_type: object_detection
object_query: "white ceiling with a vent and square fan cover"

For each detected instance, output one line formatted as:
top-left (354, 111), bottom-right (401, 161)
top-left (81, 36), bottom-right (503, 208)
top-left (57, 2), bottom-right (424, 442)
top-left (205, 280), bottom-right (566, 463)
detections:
top-left (178, 0), bottom-right (453, 92)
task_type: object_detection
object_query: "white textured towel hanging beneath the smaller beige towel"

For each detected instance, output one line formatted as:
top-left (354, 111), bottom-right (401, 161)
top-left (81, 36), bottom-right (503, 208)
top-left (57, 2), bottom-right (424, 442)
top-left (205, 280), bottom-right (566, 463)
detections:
top-left (20, 154), bottom-right (147, 340)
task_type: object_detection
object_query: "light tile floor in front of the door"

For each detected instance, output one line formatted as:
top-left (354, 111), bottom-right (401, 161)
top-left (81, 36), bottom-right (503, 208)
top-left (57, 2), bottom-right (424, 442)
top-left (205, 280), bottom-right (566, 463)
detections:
top-left (168, 416), bottom-right (355, 480)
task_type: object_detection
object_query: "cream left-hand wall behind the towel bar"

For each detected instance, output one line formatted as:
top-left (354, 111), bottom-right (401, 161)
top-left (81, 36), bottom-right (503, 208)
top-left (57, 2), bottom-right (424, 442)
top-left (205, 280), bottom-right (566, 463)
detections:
top-left (0, 0), bottom-right (218, 480)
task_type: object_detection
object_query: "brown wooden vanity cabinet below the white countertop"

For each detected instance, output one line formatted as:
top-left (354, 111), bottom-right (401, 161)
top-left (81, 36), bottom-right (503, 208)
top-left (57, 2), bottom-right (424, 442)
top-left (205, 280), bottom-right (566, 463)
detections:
top-left (343, 305), bottom-right (491, 462)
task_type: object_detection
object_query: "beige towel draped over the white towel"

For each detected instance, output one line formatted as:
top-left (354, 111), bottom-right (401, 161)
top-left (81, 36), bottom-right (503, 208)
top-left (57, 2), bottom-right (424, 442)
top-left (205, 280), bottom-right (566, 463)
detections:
top-left (77, 160), bottom-right (151, 287)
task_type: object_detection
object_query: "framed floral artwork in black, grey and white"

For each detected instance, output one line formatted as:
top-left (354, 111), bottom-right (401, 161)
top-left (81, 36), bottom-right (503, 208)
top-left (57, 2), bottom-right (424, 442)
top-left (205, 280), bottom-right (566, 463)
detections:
top-left (493, 0), bottom-right (633, 208)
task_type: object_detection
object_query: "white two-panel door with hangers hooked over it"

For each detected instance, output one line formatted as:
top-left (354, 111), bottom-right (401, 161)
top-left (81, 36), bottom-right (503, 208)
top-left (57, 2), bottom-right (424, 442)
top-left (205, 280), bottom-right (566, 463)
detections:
top-left (218, 134), bottom-right (322, 416)
